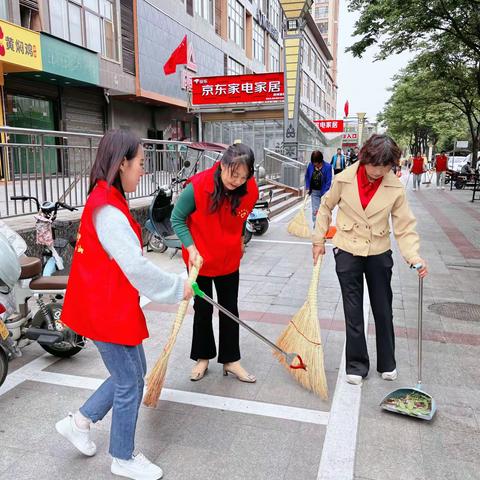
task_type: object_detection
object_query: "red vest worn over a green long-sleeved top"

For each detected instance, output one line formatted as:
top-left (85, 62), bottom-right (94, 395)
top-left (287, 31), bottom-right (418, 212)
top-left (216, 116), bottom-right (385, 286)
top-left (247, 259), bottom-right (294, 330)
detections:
top-left (182, 163), bottom-right (258, 277)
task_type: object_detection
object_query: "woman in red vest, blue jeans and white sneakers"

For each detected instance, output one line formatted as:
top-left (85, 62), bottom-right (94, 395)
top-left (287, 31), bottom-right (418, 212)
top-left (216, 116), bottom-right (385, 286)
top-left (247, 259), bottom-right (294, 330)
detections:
top-left (56, 130), bottom-right (192, 480)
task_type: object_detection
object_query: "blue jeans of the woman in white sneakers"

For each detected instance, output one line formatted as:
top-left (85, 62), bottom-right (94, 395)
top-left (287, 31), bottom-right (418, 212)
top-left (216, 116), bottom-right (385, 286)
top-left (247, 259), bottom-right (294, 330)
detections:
top-left (80, 342), bottom-right (147, 460)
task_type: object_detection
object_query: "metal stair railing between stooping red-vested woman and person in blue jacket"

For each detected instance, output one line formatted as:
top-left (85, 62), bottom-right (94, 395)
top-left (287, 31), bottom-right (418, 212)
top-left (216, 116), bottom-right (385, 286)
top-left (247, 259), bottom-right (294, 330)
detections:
top-left (256, 148), bottom-right (306, 194)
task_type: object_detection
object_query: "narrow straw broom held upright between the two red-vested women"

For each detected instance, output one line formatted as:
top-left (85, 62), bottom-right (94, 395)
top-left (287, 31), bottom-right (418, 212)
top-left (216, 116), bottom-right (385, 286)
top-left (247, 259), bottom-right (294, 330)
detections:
top-left (143, 266), bottom-right (198, 407)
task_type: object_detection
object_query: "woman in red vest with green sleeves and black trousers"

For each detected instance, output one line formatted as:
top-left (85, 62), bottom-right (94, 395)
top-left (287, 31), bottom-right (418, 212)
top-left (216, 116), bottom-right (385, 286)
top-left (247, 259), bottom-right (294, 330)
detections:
top-left (172, 143), bottom-right (258, 383)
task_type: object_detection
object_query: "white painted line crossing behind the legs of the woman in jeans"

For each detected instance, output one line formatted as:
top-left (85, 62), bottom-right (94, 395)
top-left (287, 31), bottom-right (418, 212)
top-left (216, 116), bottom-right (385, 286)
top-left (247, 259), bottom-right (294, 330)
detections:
top-left (10, 368), bottom-right (329, 425)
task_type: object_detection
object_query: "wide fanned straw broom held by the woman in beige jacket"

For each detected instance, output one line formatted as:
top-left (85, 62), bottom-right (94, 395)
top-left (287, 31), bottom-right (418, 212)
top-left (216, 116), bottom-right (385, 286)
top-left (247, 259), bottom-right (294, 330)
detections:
top-left (274, 256), bottom-right (328, 400)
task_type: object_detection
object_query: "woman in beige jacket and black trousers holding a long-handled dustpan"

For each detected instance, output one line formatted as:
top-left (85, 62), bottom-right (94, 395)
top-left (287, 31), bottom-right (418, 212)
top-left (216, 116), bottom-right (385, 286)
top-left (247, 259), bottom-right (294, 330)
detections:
top-left (313, 134), bottom-right (427, 385)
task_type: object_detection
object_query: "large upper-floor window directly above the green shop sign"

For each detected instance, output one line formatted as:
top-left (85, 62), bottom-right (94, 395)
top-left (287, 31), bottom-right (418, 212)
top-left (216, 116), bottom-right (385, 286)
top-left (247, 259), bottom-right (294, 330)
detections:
top-left (49, 0), bottom-right (118, 60)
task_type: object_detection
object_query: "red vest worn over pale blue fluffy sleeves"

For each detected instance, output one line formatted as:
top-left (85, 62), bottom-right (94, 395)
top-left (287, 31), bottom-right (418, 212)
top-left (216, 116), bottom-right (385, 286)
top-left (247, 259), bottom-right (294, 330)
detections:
top-left (62, 181), bottom-right (148, 345)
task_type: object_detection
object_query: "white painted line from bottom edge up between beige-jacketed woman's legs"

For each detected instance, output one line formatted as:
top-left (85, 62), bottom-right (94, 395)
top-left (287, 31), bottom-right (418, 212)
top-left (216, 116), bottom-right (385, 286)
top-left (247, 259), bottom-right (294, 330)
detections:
top-left (317, 280), bottom-right (370, 480)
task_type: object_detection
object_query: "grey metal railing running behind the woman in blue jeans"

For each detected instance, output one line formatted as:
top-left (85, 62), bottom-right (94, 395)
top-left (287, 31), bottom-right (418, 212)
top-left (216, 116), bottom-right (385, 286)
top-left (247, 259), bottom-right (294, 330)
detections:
top-left (0, 127), bottom-right (189, 217)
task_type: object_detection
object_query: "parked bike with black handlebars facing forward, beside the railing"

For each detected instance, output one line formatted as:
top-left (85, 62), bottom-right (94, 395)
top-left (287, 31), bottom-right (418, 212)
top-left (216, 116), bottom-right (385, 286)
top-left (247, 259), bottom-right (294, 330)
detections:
top-left (10, 195), bottom-right (77, 277)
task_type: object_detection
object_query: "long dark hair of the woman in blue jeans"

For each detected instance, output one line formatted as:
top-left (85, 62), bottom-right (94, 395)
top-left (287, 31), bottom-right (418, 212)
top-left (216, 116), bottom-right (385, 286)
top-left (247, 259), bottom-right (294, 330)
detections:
top-left (88, 130), bottom-right (142, 196)
